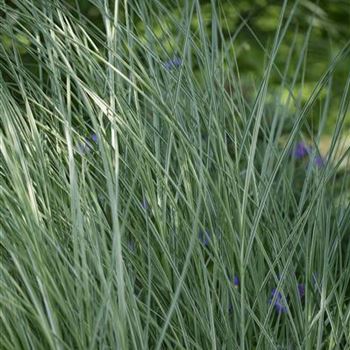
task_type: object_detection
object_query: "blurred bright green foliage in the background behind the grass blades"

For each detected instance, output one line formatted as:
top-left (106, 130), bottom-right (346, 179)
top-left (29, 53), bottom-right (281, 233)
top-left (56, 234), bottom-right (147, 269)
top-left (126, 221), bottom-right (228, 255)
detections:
top-left (0, 0), bottom-right (350, 131)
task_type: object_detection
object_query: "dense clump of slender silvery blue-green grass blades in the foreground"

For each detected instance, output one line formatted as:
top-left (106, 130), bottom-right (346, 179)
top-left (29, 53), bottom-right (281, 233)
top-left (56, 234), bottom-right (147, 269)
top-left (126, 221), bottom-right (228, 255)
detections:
top-left (0, 0), bottom-right (350, 350)
